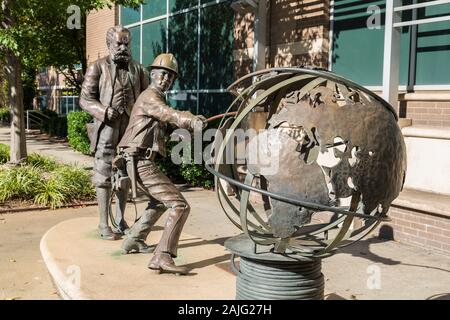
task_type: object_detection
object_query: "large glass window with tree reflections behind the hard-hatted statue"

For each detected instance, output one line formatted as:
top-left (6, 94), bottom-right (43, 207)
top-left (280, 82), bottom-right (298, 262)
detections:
top-left (122, 0), bottom-right (234, 115)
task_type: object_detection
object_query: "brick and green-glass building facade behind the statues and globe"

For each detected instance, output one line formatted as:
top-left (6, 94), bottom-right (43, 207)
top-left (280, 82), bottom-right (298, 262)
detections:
top-left (82, 0), bottom-right (450, 253)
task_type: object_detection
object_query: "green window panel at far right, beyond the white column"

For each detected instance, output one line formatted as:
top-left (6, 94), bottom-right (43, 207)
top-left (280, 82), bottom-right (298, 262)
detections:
top-left (416, 4), bottom-right (450, 85)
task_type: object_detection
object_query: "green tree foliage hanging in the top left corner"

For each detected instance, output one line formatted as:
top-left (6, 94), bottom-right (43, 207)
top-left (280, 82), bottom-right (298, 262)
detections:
top-left (0, 0), bottom-right (143, 90)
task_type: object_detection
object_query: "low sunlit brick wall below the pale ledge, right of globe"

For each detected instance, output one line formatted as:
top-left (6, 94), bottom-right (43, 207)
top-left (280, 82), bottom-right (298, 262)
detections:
top-left (380, 207), bottom-right (450, 254)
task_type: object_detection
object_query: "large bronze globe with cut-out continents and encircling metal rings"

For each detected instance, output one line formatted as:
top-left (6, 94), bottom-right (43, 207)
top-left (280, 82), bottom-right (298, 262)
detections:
top-left (206, 68), bottom-right (406, 259)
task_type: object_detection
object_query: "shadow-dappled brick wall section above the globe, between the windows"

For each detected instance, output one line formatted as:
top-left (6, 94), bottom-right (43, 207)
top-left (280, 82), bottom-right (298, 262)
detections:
top-left (233, 0), bottom-right (330, 78)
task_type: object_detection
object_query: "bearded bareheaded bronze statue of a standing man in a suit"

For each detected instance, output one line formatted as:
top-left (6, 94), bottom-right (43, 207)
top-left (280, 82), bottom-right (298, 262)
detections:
top-left (80, 26), bottom-right (149, 240)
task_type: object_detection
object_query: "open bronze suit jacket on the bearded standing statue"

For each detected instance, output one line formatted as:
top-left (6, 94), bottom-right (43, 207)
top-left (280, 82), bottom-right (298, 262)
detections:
top-left (80, 56), bottom-right (149, 151)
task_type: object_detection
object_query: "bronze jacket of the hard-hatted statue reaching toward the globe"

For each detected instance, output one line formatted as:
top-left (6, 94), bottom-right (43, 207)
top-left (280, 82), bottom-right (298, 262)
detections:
top-left (119, 87), bottom-right (197, 156)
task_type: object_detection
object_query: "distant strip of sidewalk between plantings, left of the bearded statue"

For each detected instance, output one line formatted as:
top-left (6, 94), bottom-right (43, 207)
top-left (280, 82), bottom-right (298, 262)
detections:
top-left (0, 127), bottom-right (94, 168)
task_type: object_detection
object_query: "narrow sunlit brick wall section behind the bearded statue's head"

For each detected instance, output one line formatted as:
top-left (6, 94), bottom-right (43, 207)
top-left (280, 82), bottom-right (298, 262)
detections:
top-left (86, 7), bottom-right (119, 65)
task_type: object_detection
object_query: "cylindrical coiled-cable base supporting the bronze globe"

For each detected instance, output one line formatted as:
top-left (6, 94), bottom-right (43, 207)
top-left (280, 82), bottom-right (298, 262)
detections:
top-left (225, 236), bottom-right (325, 300)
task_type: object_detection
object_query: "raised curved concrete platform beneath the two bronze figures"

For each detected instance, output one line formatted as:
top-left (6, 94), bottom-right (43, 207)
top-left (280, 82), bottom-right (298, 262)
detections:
top-left (41, 218), bottom-right (235, 300)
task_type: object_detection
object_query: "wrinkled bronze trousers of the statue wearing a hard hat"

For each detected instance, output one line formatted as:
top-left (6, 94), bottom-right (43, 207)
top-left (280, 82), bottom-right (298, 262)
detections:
top-left (127, 160), bottom-right (190, 257)
